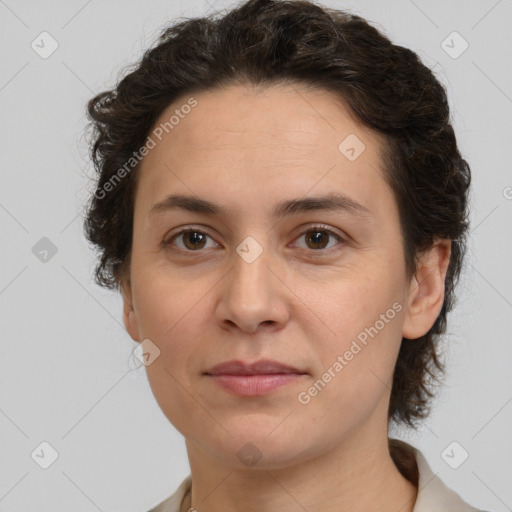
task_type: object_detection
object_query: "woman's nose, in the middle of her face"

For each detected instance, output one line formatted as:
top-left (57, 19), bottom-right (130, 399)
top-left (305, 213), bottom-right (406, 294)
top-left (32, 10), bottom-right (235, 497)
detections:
top-left (215, 241), bottom-right (293, 333)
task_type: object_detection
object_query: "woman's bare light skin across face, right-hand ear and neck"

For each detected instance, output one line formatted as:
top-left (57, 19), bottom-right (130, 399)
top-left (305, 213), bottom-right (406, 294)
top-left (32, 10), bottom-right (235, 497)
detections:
top-left (122, 84), bottom-right (450, 512)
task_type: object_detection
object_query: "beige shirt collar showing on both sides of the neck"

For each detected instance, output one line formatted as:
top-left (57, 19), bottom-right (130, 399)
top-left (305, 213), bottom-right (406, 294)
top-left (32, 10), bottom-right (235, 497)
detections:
top-left (149, 443), bottom-right (484, 512)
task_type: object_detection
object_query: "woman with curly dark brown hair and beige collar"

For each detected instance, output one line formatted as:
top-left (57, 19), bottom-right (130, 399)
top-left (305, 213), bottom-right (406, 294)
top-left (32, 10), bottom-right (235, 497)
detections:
top-left (85, 0), bottom-right (488, 512)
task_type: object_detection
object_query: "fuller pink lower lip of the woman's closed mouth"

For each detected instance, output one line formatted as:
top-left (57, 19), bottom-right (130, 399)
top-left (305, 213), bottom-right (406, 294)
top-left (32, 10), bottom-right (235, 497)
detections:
top-left (209, 373), bottom-right (302, 396)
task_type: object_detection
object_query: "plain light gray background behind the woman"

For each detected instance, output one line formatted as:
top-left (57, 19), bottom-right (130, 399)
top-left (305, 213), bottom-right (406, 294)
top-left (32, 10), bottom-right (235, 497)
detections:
top-left (0, 0), bottom-right (512, 512)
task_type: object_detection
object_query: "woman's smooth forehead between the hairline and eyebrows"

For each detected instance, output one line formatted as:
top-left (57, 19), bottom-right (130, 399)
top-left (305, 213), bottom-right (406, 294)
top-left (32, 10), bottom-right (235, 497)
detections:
top-left (137, 84), bottom-right (389, 221)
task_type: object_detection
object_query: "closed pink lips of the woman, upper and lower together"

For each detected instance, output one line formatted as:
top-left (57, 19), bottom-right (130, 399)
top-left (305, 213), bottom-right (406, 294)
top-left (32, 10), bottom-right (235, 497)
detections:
top-left (204, 360), bottom-right (307, 396)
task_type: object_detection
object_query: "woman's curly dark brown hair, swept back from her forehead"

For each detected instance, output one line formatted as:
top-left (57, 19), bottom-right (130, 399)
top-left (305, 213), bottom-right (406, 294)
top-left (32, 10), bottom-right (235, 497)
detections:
top-left (84, 0), bottom-right (471, 427)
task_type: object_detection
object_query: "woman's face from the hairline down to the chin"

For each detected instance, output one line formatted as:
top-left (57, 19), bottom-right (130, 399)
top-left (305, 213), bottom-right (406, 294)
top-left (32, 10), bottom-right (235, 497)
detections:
top-left (124, 85), bottom-right (441, 468)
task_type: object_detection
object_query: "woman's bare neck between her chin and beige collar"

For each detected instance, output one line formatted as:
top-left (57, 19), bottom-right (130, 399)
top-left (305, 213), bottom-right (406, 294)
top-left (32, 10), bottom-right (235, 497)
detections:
top-left (187, 429), bottom-right (417, 512)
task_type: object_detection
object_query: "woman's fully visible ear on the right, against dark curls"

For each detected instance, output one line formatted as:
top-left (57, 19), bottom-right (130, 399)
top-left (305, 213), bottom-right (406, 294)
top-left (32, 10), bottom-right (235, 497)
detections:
top-left (402, 239), bottom-right (451, 340)
